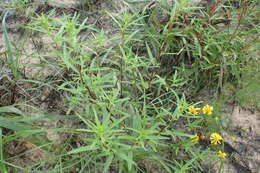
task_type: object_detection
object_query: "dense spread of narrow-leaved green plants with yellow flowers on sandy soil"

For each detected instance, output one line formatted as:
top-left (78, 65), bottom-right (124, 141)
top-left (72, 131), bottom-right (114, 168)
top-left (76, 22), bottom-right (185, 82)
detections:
top-left (0, 0), bottom-right (259, 173)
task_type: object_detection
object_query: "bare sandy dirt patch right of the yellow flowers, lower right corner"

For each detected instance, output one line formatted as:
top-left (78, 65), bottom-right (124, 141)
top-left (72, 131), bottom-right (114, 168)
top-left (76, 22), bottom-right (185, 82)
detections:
top-left (219, 106), bottom-right (260, 173)
